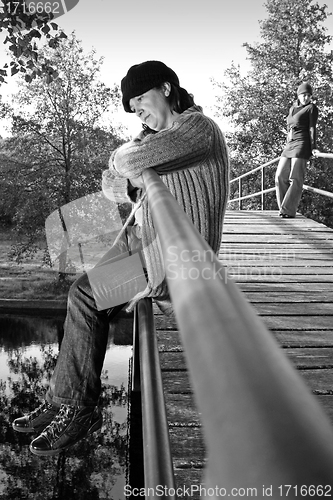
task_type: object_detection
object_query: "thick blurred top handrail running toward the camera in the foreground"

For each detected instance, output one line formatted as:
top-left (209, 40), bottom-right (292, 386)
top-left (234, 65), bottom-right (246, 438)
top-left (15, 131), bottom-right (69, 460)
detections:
top-left (142, 169), bottom-right (333, 490)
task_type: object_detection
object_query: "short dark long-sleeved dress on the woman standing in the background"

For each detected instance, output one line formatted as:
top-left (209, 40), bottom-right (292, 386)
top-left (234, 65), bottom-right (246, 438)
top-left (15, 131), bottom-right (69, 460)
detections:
top-left (281, 102), bottom-right (318, 160)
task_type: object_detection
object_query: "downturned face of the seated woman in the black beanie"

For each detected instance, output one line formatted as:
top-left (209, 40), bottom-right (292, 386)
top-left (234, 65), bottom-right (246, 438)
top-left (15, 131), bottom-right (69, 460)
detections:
top-left (129, 84), bottom-right (177, 132)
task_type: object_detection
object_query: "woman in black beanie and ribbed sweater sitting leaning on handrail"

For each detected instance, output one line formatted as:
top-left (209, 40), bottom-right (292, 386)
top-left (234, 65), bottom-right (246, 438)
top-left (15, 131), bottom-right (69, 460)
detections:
top-left (13, 61), bottom-right (229, 456)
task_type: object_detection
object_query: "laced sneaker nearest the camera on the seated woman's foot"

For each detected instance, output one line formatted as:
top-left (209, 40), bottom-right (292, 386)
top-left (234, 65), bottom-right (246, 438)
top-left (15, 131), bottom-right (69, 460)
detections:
top-left (30, 405), bottom-right (103, 456)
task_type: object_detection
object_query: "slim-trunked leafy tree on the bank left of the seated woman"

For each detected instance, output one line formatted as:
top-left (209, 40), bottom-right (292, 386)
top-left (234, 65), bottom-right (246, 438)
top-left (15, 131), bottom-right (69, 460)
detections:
top-left (0, 34), bottom-right (122, 268)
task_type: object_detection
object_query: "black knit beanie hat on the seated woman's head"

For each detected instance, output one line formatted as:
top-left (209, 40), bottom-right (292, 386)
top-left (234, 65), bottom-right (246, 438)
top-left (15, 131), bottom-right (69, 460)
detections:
top-left (121, 61), bottom-right (179, 113)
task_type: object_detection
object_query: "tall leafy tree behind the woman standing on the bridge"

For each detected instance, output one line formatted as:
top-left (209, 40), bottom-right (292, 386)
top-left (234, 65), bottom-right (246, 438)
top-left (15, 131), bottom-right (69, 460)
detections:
top-left (214, 0), bottom-right (333, 225)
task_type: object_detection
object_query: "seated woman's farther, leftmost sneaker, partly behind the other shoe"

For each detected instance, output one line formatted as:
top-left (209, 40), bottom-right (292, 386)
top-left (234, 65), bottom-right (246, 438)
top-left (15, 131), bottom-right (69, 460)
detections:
top-left (12, 401), bottom-right (59, 434)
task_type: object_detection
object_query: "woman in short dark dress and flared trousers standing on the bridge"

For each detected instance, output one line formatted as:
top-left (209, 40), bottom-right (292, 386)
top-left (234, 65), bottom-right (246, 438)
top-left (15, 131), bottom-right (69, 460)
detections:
top-left (275, 82), bottom-right (318, 218)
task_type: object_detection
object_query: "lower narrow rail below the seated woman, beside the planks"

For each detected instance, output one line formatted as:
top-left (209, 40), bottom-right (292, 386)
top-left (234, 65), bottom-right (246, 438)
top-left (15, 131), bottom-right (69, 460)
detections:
top-left (132, 299), bottom-right (175, 500)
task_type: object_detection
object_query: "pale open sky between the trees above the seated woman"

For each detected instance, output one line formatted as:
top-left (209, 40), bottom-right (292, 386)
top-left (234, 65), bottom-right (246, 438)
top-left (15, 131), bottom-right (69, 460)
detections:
top-left (0, 0), bottom-right (333, 136)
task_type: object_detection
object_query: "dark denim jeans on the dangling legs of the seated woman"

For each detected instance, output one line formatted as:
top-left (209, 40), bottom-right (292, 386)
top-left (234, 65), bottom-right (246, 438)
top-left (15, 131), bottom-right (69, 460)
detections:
top-left (46, 228), bottom-right (146, 407)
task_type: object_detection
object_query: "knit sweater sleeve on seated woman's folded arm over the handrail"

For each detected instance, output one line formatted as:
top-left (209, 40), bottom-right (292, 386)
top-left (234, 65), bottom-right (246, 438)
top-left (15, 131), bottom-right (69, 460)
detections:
top-left (110, 111), bottom-right (212, 178)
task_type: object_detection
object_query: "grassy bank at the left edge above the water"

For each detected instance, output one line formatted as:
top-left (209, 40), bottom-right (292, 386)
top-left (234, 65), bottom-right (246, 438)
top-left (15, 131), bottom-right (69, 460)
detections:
top-left (0, 227), bottom-right (71, 300)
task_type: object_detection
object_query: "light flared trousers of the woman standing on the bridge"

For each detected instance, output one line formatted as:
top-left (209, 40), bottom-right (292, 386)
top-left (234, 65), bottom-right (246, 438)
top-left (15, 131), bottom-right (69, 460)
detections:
top-left (275, 156), bottom-right (307, 217)
